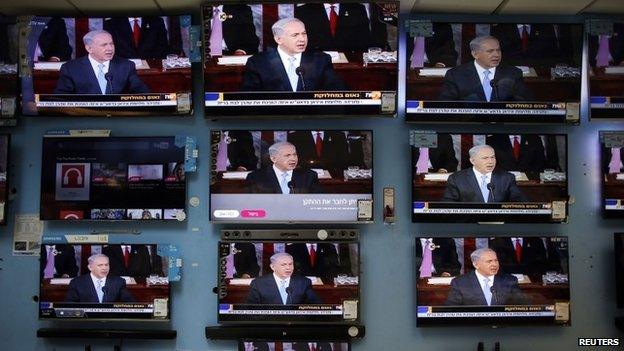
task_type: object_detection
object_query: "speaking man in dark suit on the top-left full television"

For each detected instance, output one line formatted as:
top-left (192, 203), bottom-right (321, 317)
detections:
top-left (54, 30), bottom-right (149, 94)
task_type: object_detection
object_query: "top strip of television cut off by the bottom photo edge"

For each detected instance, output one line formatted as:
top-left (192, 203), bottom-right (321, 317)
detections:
top-left (238, 340), bottom-right (351, 351)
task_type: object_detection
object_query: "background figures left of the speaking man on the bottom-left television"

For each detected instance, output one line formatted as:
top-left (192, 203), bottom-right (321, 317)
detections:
top-left (40, 244), bottom-right (78, 279)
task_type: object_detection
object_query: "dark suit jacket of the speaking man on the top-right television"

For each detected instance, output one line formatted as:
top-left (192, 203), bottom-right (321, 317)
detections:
top-left (438, 61), bottom-right (533, 101)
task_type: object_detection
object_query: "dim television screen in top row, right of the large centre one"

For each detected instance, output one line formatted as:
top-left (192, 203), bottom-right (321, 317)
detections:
top-left (406, 20), bottom-right (583, 123)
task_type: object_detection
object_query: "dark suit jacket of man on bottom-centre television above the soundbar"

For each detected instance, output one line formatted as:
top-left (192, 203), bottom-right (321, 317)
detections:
top-left (245, 273), bottom-right (322, 305)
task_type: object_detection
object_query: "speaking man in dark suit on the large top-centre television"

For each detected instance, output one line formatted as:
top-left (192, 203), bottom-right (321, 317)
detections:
top-left (241, 18), bottom-right (346, 91)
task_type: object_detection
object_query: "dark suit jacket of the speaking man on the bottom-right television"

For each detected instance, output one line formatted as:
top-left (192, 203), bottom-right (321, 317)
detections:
top-left (444, 271), bottom-right (530, 306)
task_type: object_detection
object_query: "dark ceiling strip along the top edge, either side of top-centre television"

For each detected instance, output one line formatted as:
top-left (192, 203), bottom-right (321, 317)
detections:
top-left (0, 0), bottom-right (624, 16)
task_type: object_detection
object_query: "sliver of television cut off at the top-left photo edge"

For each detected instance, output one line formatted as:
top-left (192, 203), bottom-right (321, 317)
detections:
top-left (0, 15), bottom-right (19, 121)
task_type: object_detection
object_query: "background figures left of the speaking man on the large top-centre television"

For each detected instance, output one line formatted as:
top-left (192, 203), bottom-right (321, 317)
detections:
top-left (208, 4), bottom-right (260, 56)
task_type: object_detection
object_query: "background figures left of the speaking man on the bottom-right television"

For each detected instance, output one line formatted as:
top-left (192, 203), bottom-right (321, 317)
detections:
top-left (416, 238), bottom-right (461, 278)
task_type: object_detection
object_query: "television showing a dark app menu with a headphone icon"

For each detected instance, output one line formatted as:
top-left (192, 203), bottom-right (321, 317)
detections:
top-left (40, 137), bottom-right (186, 220)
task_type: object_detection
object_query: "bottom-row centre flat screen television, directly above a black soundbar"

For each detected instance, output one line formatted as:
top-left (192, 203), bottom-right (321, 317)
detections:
top-left (217, 230), bottom-right (360, 324)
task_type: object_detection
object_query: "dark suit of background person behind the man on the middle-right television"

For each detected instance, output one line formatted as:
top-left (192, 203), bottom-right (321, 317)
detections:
top-left (485, 134), bottom-right (546, 172)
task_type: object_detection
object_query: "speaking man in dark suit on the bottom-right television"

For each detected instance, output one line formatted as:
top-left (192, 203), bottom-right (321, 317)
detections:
top-left (444, 248), bottom-right (529, 306)
